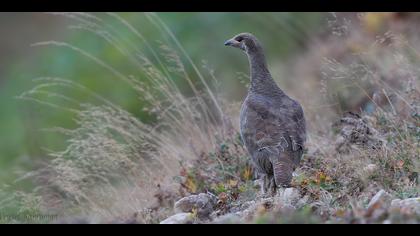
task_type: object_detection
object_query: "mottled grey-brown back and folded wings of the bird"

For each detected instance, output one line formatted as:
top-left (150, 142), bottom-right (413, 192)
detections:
top-left (240, 93), bottom-right (305, 169)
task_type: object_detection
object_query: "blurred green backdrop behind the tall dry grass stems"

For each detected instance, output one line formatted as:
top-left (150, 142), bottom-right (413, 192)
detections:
top-left (0, 13), bottom-right (326, 190)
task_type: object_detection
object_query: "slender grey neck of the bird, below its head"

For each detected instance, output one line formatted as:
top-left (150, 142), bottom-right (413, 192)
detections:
top-left (248, 49), bottom-right (283, 95)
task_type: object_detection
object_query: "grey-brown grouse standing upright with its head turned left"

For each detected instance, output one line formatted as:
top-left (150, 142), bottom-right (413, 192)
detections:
top-left (225, 33), bottom-right (306, 194)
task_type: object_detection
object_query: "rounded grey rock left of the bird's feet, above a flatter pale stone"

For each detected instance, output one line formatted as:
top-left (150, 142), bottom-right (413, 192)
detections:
top-left (174, 193), bottom-right (215, 218)
